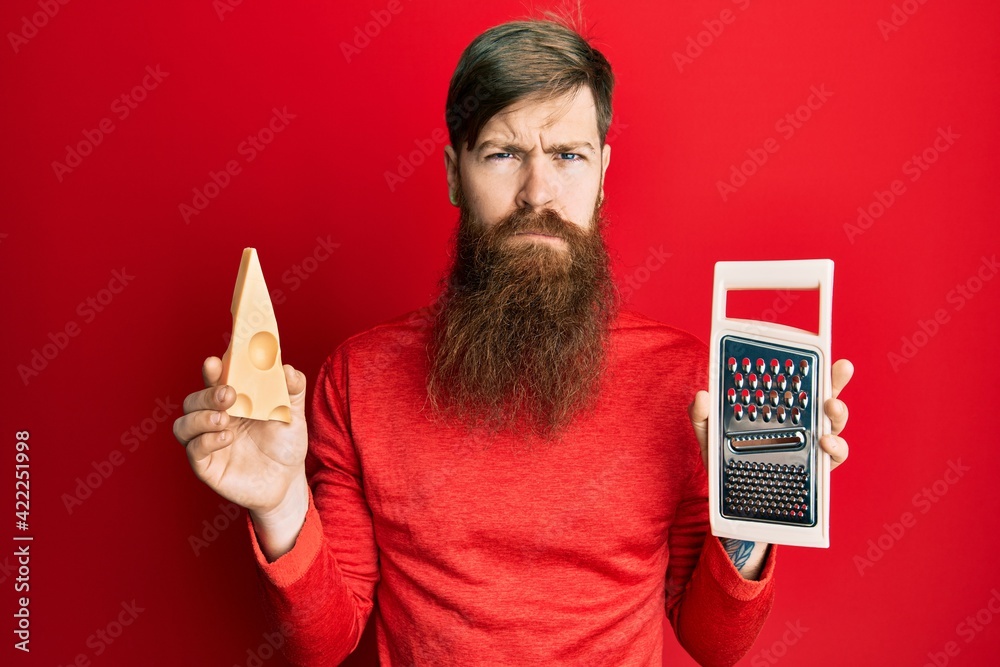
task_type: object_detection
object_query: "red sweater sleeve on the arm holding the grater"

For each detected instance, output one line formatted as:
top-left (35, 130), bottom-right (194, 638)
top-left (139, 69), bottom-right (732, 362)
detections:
top-left (666, 444), bottom-right (777, 666)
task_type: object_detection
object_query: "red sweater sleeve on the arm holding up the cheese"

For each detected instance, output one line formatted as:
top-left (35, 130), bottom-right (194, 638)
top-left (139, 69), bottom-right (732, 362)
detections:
top-left (247, 346), bottom-right (379, 665)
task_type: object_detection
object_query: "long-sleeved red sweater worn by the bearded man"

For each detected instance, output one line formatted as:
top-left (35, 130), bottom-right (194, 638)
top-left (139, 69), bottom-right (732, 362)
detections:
top-left (247, 310), bottom-right (776, 667)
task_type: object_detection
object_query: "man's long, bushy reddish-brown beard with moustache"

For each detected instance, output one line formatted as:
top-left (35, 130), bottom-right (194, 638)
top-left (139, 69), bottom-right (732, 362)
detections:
top-left (427, 187), bottom-right (619, 440)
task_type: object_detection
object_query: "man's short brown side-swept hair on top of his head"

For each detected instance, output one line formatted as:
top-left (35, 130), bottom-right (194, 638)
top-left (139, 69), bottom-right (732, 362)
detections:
top-left (445, 14), bottom-right (615, 153)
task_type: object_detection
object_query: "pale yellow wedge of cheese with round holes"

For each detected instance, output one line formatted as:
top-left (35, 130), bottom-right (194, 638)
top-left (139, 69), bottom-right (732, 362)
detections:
top-left (220, 248), bottom-right (292, 423)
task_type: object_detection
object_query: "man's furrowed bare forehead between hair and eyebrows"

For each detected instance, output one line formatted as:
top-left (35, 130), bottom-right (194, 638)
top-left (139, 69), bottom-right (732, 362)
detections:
top-left (477, 85), bottom-right (598, 146)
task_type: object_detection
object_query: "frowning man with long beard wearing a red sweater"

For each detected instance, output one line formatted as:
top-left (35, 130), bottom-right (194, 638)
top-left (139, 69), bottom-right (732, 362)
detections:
top-left (174, 21), bottom-right (851, 666)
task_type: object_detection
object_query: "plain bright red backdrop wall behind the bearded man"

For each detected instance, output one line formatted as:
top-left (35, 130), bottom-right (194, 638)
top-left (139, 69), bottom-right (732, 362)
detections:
top-left (0, 0), bottom-right (1000, 666)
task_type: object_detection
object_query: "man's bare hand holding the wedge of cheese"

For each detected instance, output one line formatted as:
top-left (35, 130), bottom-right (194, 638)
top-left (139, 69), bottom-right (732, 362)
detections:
top-left (174, 357), bottom-right (309, 560)
